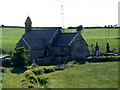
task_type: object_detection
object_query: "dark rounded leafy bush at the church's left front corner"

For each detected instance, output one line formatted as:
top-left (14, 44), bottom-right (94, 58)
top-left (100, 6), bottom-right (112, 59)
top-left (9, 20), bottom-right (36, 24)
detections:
top-left (10, 47), bottom-right (29, 68)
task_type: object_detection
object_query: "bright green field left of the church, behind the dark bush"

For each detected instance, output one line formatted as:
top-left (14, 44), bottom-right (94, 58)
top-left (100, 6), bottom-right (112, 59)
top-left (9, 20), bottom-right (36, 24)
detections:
top-left (2, 28), bottom-right (24, 52)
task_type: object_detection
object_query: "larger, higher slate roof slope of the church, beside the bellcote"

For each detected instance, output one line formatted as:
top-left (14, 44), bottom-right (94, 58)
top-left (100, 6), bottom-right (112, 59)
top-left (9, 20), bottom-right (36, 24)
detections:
top-left (22, 30), bottom-right (57, 49)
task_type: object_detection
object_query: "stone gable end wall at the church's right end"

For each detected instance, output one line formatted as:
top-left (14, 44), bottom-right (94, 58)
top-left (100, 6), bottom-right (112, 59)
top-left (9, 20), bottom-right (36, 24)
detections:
top-left (70, 34), bottom-right (89, 58)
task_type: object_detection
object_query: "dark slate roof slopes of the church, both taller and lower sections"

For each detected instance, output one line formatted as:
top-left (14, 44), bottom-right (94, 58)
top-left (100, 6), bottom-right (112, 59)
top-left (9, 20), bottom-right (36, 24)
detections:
top-left (19, 30), bottom-right (77, 49)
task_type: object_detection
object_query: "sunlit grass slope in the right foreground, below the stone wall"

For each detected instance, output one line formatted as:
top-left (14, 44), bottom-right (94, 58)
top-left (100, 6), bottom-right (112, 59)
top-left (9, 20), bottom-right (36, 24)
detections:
top-left (47, 62), bottom-right (118, 88)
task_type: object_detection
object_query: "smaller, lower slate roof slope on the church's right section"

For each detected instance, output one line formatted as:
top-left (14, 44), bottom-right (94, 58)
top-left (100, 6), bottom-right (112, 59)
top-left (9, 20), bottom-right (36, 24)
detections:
top-left (54, 33), bottom-right (77, 46)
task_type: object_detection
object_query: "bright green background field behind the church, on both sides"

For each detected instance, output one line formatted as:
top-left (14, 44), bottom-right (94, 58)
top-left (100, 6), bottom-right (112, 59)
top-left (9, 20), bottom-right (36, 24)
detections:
top-left (2, 28), bottom-right (120, 53)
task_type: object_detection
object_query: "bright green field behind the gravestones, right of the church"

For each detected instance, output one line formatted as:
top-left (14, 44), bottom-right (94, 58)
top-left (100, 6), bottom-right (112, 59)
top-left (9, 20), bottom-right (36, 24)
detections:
top-left (82, 29), bottom-right (120, 53)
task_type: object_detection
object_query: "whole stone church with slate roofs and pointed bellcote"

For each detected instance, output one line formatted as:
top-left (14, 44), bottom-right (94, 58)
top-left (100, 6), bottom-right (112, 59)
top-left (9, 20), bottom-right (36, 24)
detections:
top-left (16, 17), bottom-right (89, 64)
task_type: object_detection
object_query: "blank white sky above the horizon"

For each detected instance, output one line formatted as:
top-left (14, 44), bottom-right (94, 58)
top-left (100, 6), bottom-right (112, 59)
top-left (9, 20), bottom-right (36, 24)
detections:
top-left (0, 0), bottom-right (119, 27)
